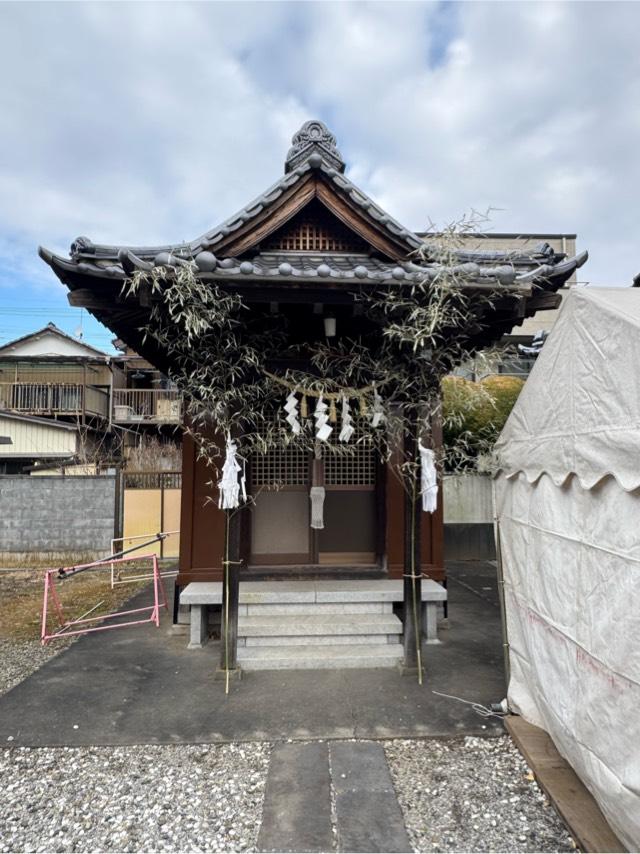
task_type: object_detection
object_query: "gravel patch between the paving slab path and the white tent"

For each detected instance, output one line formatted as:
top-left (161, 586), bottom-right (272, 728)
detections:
top-left (385, 736), bottom-right (575, 852)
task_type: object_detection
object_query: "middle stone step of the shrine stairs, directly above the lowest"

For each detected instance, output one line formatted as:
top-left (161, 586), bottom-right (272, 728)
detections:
top-left (238, 614), bottom-right (402, 643)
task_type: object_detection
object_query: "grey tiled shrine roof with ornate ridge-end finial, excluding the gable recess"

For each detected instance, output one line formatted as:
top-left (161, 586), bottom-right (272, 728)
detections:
top-left (39, 121), bottom-right (587, 294)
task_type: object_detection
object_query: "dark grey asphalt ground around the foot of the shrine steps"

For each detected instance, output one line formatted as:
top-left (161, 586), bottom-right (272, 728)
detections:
top-left (0, 562), bottom-right (506, 747)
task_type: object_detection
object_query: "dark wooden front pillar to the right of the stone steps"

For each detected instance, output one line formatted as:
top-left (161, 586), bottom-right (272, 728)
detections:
top-left (402, 430), bottom-right (423, 684)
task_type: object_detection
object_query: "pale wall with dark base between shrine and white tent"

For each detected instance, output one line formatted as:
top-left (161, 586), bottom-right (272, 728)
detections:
top-left (443, 474), bottom-right (496, 560)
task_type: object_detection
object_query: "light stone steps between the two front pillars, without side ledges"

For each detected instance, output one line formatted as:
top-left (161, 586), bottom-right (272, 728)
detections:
top-left (238, 581), bottom-right (402, 670)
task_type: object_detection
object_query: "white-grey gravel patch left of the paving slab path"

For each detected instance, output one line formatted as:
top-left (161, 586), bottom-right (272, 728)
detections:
top-left (0, 743), bottom-right (270, 852)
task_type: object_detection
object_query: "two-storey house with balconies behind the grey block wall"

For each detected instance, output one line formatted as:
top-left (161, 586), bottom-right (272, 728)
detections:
top-left (0, 323), bottom-right (182, 474)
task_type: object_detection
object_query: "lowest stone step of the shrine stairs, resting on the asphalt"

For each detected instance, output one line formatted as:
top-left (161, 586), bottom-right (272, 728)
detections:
top-left (238, 643), bottom-right (402, 670)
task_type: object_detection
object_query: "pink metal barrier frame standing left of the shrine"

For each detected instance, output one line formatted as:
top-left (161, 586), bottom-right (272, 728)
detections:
top-left (40, 554), bottom-right (169, 646)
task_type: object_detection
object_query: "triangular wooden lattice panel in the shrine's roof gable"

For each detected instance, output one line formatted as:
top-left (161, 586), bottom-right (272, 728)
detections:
top-left (262, 205), bottom-right (369, 253)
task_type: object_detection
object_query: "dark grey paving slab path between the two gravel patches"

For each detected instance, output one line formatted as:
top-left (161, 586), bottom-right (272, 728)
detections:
top-left (258, 741), bottom-right (412, 852)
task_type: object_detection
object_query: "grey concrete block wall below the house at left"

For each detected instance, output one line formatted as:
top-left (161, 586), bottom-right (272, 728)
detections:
top-left (0, 475), bottom-right (116, 560)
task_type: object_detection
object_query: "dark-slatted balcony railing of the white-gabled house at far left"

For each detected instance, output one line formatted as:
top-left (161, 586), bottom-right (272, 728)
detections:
top-left (0, 382), bottom-right (109, 420)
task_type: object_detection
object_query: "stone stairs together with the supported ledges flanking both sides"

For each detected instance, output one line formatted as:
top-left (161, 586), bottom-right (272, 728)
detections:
top-left (180, 579), bottom-right (447, 670)
